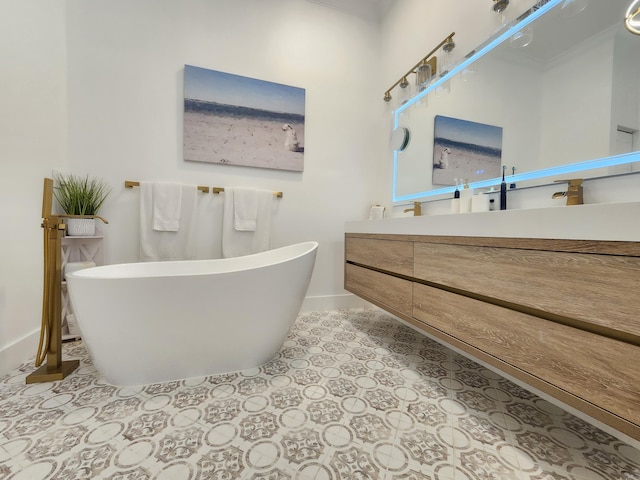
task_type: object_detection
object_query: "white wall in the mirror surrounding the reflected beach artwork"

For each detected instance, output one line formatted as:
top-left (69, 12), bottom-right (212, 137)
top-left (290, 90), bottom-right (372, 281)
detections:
top-left (396, 56), bottom-right (540, 199)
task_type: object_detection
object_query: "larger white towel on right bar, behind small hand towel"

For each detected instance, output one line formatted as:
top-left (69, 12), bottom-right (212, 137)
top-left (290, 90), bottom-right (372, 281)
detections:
top-left (222, 188), bottom-right (273, 258)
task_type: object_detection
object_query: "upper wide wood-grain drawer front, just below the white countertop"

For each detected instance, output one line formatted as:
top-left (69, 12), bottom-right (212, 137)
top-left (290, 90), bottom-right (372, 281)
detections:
top-left (415, 243), bottom-right (640, 344)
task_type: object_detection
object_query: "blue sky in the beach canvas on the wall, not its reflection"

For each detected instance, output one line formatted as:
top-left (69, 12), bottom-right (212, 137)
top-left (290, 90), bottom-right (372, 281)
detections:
top-left (184, 65), bottom-right (305, 115)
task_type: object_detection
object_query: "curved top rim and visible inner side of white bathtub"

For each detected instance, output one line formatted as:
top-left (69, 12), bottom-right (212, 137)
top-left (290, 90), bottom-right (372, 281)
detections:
top-left (66, 241), bottom-right (319, 280)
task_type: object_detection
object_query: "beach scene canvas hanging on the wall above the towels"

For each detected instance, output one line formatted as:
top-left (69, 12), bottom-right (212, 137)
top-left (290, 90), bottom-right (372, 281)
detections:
top-left (183, 65), bottom-right (305, 172)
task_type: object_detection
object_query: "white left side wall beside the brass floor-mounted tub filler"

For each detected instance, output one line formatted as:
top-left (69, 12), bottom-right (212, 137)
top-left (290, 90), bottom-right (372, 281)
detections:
top-left (0, 0), bottom-right (67, 374)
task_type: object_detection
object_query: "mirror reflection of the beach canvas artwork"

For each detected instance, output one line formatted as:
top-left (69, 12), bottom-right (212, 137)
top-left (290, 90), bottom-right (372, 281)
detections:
top-left (433, 115), bottom-right (502, 185)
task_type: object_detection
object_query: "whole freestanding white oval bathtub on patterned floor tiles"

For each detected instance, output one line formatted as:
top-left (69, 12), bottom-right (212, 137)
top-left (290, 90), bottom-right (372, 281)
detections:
top-left (66, 242), bottom-right (318, 385)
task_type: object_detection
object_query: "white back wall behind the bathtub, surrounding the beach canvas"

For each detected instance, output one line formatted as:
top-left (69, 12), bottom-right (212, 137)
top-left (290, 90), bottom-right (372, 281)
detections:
top-left (68, 0), bottom-right (378, 270)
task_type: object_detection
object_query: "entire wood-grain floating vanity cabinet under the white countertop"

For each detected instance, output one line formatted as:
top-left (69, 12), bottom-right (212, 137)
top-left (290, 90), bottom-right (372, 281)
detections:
top-left (345, 233), bottom-right (640, 440)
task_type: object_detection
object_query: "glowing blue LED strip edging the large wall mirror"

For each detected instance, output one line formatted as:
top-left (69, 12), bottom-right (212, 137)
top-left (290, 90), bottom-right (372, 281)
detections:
top-left (392, 0), bottom-right (640, 203)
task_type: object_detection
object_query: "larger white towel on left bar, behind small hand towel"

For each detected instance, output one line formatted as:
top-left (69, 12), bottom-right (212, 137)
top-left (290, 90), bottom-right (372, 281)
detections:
top-left (140, 181), bottom-right (198, 262)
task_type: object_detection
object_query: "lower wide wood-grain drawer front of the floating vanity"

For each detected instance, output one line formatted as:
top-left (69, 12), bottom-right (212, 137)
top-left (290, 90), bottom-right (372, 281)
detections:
top-left (413, 284), bottom-right (640, 438)
